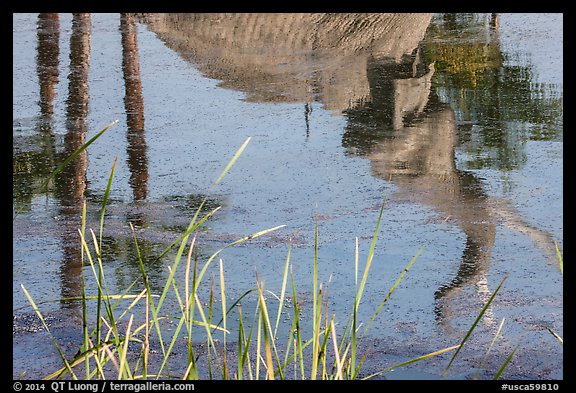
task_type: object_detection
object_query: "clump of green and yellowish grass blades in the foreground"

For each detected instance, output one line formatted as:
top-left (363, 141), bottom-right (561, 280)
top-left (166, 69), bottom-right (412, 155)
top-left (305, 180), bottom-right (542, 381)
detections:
top-left (22, 130), bottom-right (509, 380)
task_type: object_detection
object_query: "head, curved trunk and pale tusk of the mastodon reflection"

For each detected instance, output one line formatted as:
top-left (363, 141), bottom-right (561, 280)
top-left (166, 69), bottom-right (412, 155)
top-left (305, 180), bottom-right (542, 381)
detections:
top-left (343, 43), bottom-right (552, 330)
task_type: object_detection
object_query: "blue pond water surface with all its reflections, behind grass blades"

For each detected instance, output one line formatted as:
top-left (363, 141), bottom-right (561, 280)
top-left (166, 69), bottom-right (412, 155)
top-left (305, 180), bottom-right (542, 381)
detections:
top-left (12, 13), bottom-right (563, 380)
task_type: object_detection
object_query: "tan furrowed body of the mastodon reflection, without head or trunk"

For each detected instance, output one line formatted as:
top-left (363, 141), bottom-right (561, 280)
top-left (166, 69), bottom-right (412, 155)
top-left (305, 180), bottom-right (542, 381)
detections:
top-left (143, 13), bottom-right (432, 111)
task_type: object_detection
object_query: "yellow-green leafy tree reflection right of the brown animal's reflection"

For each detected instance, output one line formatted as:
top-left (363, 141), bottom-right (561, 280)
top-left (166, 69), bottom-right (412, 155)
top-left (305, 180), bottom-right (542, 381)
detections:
top-left (424, 14), bottom-right (563, 171)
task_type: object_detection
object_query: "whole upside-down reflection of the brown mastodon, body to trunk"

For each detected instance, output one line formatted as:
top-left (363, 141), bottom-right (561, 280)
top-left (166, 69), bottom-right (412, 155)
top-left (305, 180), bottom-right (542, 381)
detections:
top-left (142, 14), bottom-right (551, 328)
